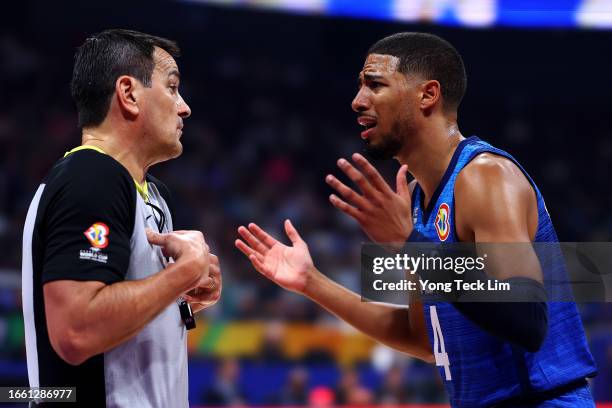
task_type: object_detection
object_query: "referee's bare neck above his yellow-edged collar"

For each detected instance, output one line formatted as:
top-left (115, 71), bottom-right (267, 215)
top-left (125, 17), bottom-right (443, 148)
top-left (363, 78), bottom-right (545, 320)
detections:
top-left (82, 127), bottom-right (147, 183)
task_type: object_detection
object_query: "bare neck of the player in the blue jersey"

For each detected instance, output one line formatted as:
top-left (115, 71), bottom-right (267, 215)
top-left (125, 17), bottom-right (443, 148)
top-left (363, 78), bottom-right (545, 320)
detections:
top-left (398, 123), bottom-right (465, 205)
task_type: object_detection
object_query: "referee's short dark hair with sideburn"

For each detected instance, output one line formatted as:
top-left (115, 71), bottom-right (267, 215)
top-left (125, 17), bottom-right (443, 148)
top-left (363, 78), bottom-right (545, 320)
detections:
top-left (70, 29), bottom-right (180, 127)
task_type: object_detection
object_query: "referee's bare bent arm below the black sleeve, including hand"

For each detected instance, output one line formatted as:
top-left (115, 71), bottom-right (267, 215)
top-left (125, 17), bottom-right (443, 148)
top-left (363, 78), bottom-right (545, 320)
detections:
top-left (43, 231), bottom-right (209, 365)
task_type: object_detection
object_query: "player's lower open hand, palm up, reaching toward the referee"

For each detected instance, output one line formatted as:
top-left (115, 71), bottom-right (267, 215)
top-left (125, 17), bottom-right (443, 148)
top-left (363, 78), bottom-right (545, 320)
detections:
top-left (235, 220), bottom-right (315, 294)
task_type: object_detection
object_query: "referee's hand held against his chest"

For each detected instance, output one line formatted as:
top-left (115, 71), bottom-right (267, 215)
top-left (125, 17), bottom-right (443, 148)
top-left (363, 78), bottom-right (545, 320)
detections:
top-left (146, 229), bottom-right (211, 288)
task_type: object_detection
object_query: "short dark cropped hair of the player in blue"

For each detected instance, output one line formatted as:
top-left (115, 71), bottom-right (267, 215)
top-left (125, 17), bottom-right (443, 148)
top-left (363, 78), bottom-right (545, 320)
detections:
top-left (368, 32), bottom-right (467, 111)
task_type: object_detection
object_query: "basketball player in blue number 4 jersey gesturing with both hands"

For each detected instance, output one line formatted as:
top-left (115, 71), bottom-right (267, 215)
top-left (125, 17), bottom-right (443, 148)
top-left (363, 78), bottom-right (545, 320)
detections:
top-left (236, 33), bottom-right (596, 408)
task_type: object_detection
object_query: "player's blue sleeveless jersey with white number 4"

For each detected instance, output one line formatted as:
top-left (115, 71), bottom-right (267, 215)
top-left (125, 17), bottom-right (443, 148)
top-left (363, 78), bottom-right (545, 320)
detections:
top-left (412, 136), bottom-right (596, 408)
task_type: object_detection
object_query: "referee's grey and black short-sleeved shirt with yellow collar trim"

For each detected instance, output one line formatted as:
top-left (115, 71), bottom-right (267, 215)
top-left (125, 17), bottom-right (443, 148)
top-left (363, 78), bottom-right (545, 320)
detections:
top-left (22, 149), bottom-right (189, 408)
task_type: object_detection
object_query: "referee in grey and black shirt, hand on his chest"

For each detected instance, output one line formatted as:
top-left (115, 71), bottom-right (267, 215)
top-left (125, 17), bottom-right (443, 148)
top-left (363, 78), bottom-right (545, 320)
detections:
top-left (22, 30), bottom-right (221, 408)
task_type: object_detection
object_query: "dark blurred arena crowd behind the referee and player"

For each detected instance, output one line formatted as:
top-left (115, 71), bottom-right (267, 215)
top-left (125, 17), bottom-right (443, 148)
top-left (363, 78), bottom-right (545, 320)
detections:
top-left (0, 1), bottom-right (612, 405)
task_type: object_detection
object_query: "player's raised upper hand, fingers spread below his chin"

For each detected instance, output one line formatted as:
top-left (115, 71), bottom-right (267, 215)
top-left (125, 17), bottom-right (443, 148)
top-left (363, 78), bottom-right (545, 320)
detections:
top-left (325, 153), bottom-right (413, 250)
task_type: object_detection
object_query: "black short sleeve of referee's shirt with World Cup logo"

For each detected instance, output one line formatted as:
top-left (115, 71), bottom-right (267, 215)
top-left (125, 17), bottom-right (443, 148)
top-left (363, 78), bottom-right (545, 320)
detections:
top-left (42, 151), bottom-right (136, 284)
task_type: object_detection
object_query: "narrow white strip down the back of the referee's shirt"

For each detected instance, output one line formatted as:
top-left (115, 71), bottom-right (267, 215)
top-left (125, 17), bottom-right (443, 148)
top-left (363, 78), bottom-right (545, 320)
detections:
top-left (21, 184), bottom-right (45, 387)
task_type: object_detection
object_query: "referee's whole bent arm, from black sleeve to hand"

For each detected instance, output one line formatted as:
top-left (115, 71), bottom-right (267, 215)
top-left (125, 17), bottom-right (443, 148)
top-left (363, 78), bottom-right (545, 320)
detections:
top-left (40, 159), bottom-right (209, 365)
